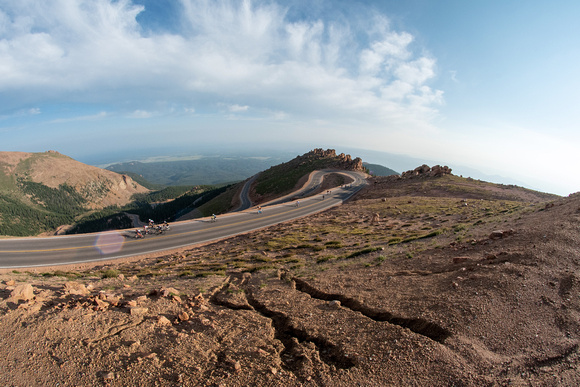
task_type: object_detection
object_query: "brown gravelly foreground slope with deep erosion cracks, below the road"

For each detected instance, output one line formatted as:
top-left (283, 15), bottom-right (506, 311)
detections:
top-left (0, 177), bottom-right (580, 386)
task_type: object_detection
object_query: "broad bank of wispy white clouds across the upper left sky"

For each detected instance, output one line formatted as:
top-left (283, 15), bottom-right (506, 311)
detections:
top-left (0, 0), bottom-right (443, 126)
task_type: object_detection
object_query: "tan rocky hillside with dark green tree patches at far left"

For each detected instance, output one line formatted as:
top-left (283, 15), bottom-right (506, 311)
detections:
top-left (0, 151), bottom-right (149, 235)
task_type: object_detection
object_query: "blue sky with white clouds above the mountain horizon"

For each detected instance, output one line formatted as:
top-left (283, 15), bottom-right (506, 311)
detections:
top-left (0, 0), bottom-right (580, 195)
